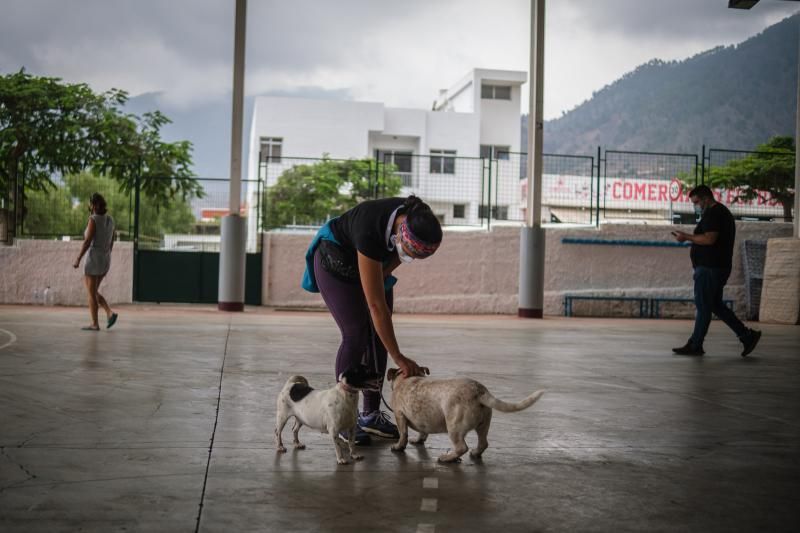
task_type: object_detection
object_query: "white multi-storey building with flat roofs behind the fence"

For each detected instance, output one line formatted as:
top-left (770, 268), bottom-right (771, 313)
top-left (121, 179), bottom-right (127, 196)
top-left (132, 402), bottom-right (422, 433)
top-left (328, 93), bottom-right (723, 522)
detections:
top-left (248, 69), bottom-right (527, 238)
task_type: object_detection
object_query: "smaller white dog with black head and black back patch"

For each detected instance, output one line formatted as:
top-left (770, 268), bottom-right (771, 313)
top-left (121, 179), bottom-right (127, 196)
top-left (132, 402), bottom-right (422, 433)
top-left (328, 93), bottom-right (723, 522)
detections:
top-left (275, 366), bottom-right (380, 465)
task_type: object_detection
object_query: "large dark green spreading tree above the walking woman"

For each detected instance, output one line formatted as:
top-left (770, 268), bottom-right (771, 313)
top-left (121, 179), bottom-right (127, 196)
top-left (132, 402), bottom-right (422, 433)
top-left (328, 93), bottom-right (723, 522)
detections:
top-left (0, 69), bottom-right (202, 243)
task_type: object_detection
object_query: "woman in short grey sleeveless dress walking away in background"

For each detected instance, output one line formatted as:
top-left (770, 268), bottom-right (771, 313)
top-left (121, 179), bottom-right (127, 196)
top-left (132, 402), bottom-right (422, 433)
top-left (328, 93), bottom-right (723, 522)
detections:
top-left (72, 193), bottom-right (117, 331)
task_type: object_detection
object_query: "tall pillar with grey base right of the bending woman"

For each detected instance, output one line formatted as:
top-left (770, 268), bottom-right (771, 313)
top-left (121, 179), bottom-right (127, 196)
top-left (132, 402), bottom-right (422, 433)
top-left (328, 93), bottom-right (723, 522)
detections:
top-left (517, 0), bottom-right (545, 318)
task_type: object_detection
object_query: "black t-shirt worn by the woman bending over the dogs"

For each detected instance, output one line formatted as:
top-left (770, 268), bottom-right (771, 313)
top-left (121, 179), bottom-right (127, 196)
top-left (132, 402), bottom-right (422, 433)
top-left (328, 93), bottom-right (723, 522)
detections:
top-left (331, 198), bottom-right (405, 263)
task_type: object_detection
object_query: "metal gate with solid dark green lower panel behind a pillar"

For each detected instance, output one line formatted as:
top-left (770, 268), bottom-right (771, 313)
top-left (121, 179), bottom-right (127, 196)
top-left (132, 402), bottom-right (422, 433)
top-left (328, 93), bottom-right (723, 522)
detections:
top-left (133, 179), bottom-right (262, 305)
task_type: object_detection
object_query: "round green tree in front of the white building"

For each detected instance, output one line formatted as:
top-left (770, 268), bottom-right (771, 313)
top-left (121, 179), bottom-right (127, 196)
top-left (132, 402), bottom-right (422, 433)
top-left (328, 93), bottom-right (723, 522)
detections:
top-left (263, 157), bottom-right (402, 228)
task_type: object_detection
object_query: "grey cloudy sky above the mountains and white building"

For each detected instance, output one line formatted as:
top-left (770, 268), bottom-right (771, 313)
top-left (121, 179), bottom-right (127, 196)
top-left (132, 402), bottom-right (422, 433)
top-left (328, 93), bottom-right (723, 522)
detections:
top-left (0, 0), bottom-right (800, 118)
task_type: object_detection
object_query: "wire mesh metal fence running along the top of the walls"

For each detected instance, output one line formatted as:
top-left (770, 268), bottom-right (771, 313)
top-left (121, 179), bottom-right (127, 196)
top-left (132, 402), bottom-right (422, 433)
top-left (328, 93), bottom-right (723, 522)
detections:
top-left (7, 143), bottom-right (794, 239)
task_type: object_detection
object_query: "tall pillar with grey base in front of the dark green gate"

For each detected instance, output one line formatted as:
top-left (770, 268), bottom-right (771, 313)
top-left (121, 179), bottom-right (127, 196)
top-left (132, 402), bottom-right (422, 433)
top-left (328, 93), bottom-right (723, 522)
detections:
top-left (217, 0), bottom-right (247, 311)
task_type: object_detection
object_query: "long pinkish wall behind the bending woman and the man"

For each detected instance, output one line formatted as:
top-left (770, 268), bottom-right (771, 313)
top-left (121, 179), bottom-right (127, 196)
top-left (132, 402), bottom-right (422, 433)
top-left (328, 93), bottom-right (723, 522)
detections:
top-left (263, 222), bottom-right (792, 316)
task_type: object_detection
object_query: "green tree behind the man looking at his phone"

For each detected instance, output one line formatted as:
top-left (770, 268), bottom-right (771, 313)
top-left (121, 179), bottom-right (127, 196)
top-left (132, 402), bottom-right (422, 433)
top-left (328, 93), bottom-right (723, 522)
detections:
top-left (708, 136), bottom-right (796, 222)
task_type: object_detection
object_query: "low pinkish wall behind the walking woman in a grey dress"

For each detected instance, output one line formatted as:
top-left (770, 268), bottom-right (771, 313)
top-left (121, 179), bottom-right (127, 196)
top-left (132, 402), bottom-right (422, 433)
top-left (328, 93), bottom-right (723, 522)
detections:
top-left (0, 240), bottom-right (133, 305)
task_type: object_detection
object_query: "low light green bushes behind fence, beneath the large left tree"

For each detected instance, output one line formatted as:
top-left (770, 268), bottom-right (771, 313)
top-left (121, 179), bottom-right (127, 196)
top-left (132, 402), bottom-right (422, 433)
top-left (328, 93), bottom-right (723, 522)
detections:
top-left (23, 172), bottom-right (195, 240)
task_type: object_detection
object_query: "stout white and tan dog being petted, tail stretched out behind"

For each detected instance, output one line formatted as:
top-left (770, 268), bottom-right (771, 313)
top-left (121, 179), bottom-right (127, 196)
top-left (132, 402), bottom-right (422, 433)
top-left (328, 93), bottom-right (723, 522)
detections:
top-left (386, 368), bottom-right (544, 463)
